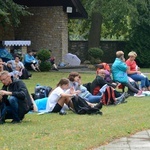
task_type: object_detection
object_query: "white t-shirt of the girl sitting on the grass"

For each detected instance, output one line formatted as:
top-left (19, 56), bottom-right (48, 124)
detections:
top-left (46, 86), bottom-right (64, 111)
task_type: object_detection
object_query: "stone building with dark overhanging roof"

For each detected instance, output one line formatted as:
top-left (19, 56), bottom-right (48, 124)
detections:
top-left (0, 0), bottom-right (87, 63)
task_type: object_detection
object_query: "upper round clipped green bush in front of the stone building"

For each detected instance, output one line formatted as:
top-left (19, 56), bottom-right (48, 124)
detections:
top-left (37, 49), bottom-right (50, 61)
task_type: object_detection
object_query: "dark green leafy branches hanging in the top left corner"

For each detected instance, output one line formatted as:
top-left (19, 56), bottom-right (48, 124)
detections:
top-left (0, 0), bottom-right (31, 27)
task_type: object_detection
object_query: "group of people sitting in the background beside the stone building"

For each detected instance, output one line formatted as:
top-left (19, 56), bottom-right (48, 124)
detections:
top-left (0, 50), bottom-right (58, 79)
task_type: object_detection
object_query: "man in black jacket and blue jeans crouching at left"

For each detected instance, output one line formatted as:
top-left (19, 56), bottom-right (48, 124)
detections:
top-left (0, 71), bottom-right (33, 124)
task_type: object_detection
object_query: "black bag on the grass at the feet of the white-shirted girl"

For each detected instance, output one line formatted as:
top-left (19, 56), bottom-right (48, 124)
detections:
top-left (71, 96), bottom-right (102, 115)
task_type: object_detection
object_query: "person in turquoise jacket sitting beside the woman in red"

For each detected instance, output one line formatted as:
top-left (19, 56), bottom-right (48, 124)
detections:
top-left (112, 51), bottom-right (142, 95)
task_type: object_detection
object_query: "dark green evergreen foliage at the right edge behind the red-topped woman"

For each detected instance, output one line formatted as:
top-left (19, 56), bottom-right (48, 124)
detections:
top-left (126, 0), bottom-right (150, 67)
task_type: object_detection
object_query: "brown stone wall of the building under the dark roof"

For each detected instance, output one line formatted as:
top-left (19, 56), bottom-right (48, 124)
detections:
top-left (15, 6), bottom-right (68, 62)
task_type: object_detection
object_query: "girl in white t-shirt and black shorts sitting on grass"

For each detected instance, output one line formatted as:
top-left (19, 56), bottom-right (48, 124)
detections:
top-left (46, 78), bottom-right (102, 115)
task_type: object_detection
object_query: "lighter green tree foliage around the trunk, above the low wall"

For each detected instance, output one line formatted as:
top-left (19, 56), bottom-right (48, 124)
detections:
top-left (69, 0), bottom-right (149, 39)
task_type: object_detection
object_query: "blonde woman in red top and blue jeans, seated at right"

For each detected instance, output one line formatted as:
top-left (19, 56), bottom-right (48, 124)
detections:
top-left (126, 51), bottom-right (150, 91)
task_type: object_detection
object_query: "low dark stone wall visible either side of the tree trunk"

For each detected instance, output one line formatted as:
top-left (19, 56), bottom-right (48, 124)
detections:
top-left (68, 41), bottom-right (125, 63)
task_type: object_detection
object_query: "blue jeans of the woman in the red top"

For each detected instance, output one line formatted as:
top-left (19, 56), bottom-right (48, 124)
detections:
top-left (128, 73), bottom-right (150, 88)
